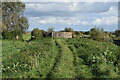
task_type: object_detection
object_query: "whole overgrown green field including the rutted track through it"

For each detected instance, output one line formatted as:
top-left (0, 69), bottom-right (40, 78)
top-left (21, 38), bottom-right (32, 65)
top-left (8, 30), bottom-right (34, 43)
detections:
top-left (2, 35), bottom-right (120, 78)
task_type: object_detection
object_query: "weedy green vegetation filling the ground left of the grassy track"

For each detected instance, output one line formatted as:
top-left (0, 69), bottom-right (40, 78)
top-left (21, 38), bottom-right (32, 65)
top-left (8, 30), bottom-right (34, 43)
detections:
top-left (2, 39), bottom-right (57, 78)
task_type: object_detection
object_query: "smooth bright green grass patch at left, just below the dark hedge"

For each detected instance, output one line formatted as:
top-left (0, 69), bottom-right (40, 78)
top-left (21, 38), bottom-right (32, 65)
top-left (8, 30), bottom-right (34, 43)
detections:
top-left (2, 40), bottom-right (26, 57)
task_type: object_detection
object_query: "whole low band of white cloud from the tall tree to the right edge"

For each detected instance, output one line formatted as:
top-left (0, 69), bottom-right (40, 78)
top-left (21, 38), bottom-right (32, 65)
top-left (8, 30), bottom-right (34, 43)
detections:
top-left (29, 16), bottom-right (118, 26)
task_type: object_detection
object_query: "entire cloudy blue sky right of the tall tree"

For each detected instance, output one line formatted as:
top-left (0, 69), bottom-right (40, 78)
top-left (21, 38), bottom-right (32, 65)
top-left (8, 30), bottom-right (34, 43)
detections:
top-left (24, 2), bottom-right (118, 31)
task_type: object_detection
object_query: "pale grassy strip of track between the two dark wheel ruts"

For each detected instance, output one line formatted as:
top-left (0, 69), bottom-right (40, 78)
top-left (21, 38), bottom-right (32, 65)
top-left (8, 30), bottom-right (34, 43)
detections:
top-left (51, 39), bottom-right (75, 78)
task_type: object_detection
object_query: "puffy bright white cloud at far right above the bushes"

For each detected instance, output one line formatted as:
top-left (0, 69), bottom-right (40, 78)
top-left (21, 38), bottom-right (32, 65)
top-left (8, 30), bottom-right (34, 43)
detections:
top-left (92, 16), bottom-right (118, 25)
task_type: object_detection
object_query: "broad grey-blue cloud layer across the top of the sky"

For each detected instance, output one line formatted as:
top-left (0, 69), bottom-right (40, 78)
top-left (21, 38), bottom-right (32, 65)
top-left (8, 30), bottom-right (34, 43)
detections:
top-left (25, 2), bottom-right (116, 16)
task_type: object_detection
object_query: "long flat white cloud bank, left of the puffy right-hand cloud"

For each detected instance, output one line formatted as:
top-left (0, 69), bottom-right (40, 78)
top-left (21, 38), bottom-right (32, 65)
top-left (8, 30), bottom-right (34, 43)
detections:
top-left (29, 16), bottom-right (89, 25)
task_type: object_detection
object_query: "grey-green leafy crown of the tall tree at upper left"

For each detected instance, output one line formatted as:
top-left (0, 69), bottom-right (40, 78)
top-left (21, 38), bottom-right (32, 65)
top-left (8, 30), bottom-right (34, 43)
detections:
top-left (2, 2), bottom-right (29, 31)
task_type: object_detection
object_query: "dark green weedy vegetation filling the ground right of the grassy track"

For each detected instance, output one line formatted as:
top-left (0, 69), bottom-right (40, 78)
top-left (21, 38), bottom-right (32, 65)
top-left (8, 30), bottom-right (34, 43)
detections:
top-left (66, 38), bottom-right (119, 78)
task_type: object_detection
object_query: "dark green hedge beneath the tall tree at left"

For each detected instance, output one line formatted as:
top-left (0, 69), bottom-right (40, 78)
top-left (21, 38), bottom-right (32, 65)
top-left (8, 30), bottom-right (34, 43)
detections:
top-left (2, 30), bottom-right (22, 40)
